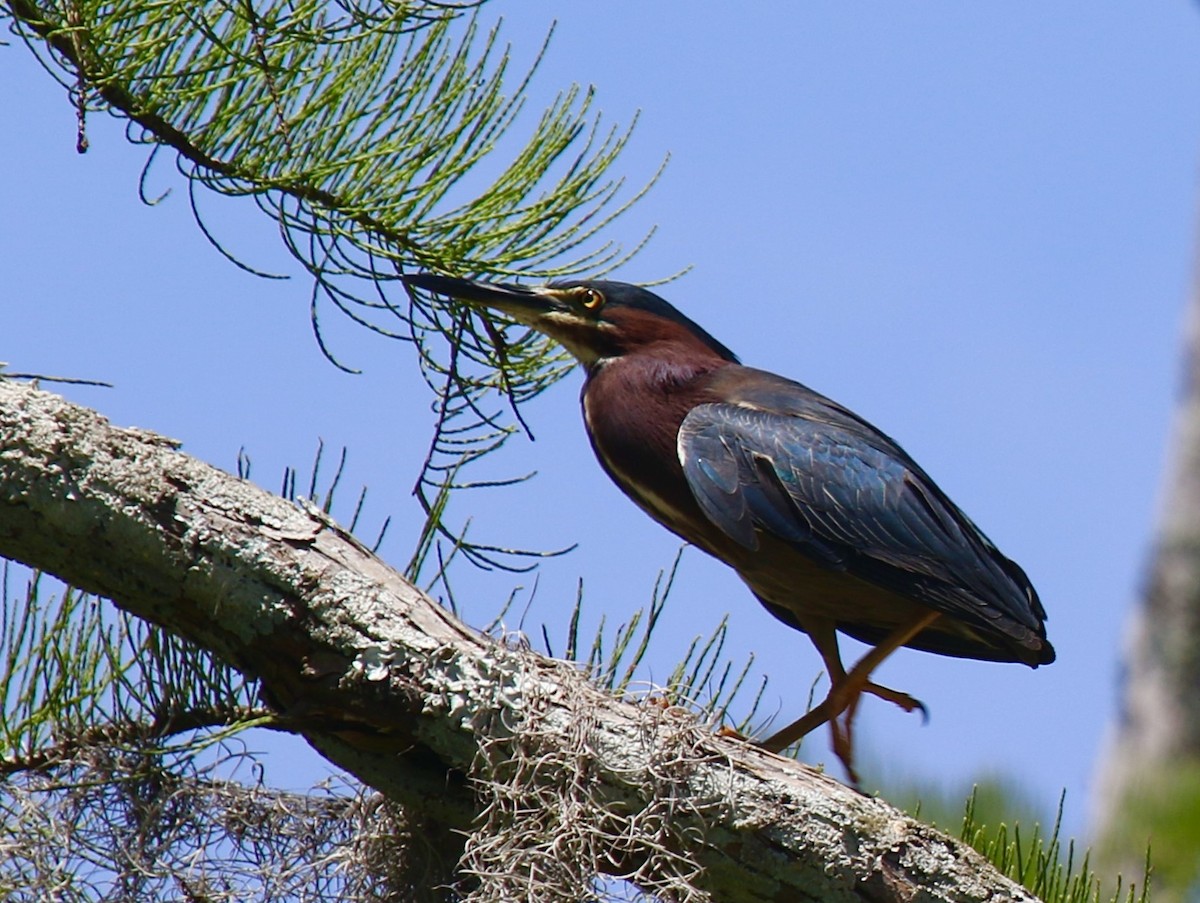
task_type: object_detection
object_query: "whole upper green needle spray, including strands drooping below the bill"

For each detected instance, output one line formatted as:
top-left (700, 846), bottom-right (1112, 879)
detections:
top-left (0, 0), bottom-right (656, 585)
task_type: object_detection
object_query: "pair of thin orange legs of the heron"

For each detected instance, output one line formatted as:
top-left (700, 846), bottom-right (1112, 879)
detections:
top-left (760, 611), bottom-right (941, 784)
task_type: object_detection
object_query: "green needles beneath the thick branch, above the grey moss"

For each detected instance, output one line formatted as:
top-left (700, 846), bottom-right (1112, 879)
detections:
top-left (0, 562), bottom-right (269, 778)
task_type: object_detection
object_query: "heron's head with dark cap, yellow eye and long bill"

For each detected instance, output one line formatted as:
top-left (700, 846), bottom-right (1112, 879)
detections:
top-left (404, 273), bottom-right (737, 367)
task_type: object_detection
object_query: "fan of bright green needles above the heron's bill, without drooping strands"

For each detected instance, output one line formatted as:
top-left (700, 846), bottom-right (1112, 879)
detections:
top-left (7, 0), bottom-right (652, 282)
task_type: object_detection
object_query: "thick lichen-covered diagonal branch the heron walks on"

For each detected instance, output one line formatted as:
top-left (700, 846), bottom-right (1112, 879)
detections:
top-left (0, 381), bottom-right (1034, 901)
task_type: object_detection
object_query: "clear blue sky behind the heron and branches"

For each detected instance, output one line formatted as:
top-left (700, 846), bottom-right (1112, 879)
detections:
top-left (0, 0), bottom-right (1200, 830)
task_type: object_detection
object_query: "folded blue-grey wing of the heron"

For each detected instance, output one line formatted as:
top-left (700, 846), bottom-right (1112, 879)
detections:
top-left (678, 369), bottom-right (1045, 636)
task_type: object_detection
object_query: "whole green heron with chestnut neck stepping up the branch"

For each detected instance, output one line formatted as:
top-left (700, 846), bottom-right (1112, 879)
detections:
top-left (406, 274), bottom-right (1055, 781)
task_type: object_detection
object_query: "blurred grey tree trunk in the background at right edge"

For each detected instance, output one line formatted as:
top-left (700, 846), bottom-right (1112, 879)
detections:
top-left (1094, 255), bottom-right (1200, 903)
